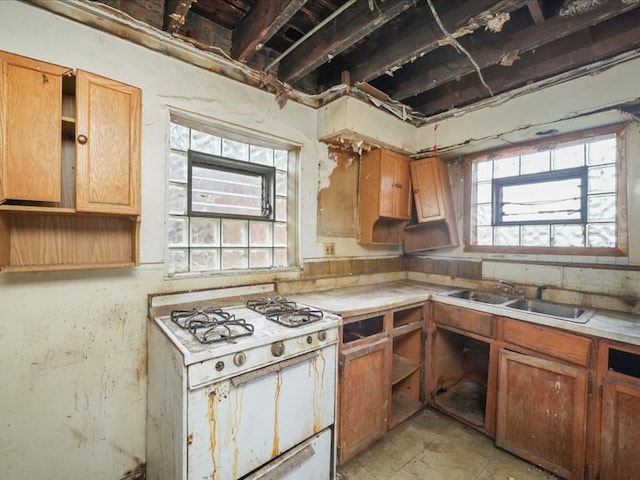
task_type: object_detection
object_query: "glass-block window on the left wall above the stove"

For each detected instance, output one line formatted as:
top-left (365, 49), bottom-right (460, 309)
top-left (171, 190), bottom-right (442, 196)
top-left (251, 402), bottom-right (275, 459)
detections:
top-left (167, 117), bottom-right (297, 275)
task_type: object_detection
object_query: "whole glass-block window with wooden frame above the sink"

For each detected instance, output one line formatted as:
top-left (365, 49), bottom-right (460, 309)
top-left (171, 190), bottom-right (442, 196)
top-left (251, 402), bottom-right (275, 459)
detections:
top-left (465, 127), bottom-right (626, 255)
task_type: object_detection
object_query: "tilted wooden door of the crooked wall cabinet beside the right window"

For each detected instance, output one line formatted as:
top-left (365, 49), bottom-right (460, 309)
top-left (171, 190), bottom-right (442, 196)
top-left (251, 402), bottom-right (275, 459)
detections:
top-left (411, 157), bottom-right (451, 222)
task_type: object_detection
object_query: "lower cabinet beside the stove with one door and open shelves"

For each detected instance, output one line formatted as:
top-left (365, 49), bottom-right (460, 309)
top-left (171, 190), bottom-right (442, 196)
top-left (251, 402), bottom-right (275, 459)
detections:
top-left (338, 303), bottom-right (425, 465)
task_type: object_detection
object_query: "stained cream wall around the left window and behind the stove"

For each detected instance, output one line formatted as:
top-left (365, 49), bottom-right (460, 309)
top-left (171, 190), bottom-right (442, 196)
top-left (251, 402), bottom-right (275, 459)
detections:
top-left (0, 1), bottom-right (327, 480)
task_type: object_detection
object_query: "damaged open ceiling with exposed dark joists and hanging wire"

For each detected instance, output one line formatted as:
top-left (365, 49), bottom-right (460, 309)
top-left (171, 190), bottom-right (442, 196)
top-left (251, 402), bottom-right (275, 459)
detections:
top-left (36, 0), bottom-right (640, 123)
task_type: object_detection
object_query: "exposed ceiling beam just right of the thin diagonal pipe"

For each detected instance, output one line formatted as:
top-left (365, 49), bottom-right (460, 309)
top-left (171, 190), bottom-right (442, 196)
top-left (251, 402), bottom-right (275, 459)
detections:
top-left (279, 0), bottom-right (418, 82)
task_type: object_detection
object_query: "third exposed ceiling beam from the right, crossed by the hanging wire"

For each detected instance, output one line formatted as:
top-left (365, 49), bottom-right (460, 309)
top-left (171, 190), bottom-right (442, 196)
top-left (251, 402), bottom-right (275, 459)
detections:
top-left (350, 0), bottom-right (526, 82)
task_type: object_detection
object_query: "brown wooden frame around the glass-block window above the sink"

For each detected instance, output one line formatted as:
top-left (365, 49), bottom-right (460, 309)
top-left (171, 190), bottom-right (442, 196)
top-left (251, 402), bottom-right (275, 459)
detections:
top-left (463, 122), bottom-right (628, 257)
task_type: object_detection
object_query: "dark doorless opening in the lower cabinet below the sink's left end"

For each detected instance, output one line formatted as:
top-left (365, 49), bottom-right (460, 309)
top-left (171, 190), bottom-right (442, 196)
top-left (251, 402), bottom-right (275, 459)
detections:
top-left (432, 328), bottom-right (490, 427)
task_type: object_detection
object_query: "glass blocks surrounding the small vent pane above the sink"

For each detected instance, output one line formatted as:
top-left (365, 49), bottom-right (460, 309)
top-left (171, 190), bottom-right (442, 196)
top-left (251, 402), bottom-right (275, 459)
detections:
top-left (471, 134), bottom-right (617, 248)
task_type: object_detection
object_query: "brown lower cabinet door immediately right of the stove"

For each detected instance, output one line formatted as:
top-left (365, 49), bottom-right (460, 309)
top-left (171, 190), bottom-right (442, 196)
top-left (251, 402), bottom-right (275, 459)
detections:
top-left (338, 338), bottom-right (390, 464)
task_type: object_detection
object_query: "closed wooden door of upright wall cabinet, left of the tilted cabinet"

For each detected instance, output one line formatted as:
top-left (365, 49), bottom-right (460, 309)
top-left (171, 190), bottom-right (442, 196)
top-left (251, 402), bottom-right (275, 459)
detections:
top-left (379, 150), bottom-right (411, 220)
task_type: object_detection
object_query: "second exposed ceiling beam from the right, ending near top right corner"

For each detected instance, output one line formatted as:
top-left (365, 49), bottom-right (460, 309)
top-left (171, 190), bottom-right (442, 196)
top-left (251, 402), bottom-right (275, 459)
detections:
top-left (389, 0), bottom-right (640, 100)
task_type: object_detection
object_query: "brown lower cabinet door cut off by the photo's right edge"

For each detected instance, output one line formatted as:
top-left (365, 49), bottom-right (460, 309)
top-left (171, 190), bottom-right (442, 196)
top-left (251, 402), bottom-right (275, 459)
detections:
top-left (600, 379), bottom-right (640, 480)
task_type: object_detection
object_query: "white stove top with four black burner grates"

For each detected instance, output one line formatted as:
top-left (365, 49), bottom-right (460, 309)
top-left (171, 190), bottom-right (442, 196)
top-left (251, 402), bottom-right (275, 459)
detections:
top-left (152, 291), bottom-right (341, 368)
